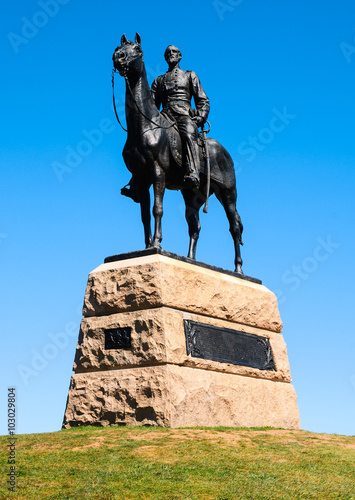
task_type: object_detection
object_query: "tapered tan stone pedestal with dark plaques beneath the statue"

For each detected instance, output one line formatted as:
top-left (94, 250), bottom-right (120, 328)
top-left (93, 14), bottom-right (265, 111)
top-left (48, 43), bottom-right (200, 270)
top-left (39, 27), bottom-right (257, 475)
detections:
top-left (63, 251), bottom-right (300, 429)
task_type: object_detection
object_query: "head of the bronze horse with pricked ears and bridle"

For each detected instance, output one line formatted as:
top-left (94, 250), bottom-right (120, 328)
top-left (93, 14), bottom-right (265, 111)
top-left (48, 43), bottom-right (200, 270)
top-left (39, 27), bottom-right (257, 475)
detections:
top-left (112, 33), bottom-right (143, 76)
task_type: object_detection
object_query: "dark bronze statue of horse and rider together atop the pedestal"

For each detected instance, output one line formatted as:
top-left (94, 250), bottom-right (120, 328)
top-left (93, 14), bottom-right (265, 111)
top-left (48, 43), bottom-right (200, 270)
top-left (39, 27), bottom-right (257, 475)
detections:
top-left (112, 33), bottom-right (243, 274)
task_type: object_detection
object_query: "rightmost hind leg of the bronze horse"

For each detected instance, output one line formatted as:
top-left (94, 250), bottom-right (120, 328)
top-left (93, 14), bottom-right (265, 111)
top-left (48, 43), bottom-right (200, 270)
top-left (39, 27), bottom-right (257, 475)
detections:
top-left (217, 188), bottom-right (243, 274)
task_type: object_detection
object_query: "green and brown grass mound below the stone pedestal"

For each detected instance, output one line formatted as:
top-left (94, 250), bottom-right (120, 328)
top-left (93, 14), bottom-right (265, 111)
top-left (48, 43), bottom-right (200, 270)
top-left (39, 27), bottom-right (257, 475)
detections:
top-left (0, 427), bottom-right (355, 500)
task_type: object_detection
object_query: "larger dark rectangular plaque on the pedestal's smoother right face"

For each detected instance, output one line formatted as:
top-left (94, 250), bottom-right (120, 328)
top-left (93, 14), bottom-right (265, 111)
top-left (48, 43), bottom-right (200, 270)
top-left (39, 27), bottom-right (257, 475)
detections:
top-left (184, 320), bottom-right (276, 370)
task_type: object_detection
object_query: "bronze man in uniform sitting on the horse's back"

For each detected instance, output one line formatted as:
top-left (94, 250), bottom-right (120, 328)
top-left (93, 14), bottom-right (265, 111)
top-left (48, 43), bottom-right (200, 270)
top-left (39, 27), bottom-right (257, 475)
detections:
top-left (121, 45), bottom-right (210, 201)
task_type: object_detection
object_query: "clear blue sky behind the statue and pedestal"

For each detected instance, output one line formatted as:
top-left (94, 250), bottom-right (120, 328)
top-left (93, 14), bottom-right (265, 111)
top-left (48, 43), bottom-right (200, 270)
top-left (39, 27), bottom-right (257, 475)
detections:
top-left (0, 0), bottom-right (355, 434)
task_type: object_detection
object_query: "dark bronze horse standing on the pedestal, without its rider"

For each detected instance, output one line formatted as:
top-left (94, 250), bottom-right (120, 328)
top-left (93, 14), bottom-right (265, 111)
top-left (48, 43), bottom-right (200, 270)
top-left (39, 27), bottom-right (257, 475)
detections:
top-left (112, 33), bottom-right (243, 274)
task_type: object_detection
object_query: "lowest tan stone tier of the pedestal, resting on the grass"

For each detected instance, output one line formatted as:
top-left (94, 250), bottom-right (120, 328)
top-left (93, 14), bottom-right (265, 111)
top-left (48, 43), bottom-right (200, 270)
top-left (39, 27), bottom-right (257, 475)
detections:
top-left (63, 365), bottom-right (300, 429)
